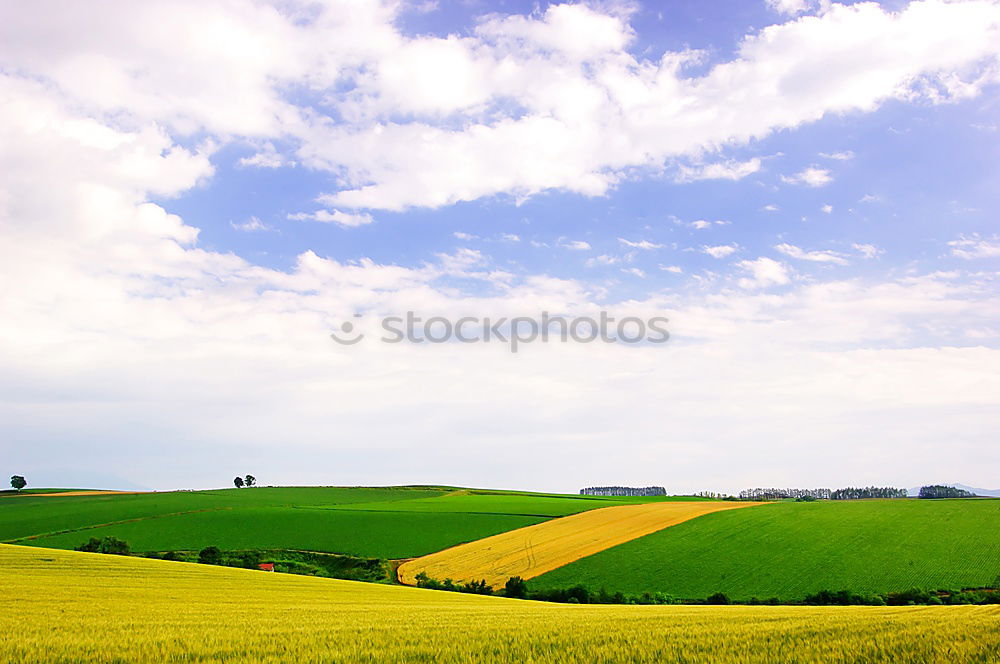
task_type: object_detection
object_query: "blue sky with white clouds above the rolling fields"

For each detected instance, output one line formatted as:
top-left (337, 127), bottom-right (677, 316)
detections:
top-left (0, 0), bottom-right (1000, 493)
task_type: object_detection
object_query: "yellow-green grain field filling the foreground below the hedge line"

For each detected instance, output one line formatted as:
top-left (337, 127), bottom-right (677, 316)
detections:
top-left (0, 545), bottom-right (1000, 664)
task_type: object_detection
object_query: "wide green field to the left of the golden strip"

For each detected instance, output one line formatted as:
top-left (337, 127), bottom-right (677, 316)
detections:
top-left (0, 487), bottom-right (672, 558)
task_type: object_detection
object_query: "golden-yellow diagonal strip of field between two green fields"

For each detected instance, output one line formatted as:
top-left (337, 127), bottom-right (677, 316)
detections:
top-left (399, 501), bottom-right (762, 588)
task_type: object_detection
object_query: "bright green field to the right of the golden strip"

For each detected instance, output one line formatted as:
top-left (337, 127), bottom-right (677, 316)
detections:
top-left (531, 499), bottom-right (1000, 600)
